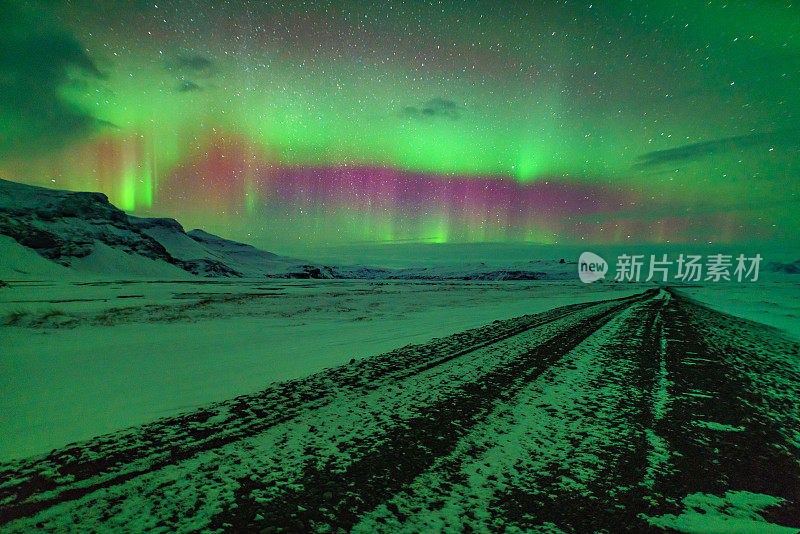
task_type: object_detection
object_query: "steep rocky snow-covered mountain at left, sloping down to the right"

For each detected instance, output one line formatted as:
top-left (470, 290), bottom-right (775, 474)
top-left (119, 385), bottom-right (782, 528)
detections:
top-left (0, 180), bottom-right (322, 278)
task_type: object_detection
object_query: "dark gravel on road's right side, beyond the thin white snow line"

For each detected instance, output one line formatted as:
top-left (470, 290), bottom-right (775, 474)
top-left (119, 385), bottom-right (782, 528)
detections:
top-left (648, 298), bottom-right (800, 532)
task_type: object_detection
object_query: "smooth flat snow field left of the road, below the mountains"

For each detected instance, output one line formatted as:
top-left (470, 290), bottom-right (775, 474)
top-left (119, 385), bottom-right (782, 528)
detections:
top-left (0, 280), bottom-right (642, 460)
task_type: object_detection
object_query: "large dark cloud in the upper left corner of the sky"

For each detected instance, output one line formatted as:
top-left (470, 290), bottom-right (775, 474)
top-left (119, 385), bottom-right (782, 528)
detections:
top-left (0, 0), bottom-right (102, 154)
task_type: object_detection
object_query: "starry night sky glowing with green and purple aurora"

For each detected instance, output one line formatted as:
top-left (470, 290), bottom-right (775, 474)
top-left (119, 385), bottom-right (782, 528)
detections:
top-left (0, 0), bottom-right (800, 252)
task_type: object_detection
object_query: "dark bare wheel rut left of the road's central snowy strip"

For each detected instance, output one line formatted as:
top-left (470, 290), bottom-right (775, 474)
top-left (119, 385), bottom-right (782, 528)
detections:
top-left (212, 291), bottom-right (658, 532)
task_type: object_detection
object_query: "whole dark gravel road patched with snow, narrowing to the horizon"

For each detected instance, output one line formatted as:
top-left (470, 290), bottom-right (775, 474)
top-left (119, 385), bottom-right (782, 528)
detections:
top-left (0, 289), bottom-right (800, 533)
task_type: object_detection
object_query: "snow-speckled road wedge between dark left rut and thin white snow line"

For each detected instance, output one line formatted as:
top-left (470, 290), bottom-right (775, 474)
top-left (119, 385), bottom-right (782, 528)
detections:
top-left (336, 298), bottom-right (664, 533)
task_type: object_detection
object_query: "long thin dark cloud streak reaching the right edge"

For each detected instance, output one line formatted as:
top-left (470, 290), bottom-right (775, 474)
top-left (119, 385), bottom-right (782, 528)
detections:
top-left (636, 129), bottom-right (800, 168)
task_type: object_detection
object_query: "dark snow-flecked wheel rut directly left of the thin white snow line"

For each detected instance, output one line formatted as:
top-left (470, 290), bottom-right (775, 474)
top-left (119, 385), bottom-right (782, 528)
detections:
top-left (494, 298), bottom-right (668, 532)
